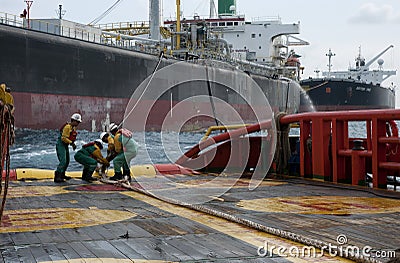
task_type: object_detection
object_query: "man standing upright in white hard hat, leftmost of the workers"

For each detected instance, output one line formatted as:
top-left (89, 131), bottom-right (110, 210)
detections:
top-left (54, 113), bottom-right (82, 183)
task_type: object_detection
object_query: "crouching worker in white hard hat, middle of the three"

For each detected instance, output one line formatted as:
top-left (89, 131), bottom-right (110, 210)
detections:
top-left (74, 139), bottom-right (110, 182)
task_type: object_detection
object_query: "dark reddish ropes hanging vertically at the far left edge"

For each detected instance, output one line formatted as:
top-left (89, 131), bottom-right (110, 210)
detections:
top-left (0, 100), bottom-right (15, 224)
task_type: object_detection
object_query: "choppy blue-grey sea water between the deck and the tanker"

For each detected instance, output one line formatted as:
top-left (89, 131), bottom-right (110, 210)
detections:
top-left (10, 122), bottom-right (366, 171)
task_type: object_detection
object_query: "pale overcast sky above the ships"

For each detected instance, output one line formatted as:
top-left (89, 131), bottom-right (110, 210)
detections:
top-left (0, 0), bottom-right (400, 108)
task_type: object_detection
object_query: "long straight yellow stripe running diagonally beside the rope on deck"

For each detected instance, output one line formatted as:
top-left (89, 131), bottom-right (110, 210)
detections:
top-left (122, 192), bottom-right (353, 262)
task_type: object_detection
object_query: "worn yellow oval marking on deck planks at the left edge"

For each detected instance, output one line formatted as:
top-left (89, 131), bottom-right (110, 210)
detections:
top-left (0, 208), bottom-right (137, 233)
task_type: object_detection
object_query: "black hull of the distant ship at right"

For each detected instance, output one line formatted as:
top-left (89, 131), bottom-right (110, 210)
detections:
top-left (300, 78), bottom-right (395, 111)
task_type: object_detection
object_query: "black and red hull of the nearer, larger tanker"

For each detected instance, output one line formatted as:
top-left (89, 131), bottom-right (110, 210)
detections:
top-left (0, 24), bottom-right (301, 130)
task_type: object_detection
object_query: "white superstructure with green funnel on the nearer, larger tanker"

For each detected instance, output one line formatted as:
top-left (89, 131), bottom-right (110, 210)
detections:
top-left (164, 0), bottom-right (309, 79)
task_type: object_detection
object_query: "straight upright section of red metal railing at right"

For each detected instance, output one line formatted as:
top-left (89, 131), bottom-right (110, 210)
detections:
top-left (280, 110), bottom-right (400, 188)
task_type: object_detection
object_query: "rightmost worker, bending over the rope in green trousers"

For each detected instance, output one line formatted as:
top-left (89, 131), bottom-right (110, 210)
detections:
top-left (110, 126), bottom-right (138, 181)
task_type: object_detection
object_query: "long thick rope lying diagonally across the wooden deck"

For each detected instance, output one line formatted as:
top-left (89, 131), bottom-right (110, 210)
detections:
top-left (100, 178), bottom-right (382, 263)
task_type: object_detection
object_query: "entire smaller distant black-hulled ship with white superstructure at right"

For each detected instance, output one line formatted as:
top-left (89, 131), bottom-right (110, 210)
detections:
top-left (300, 46), bottom-right (396, 111)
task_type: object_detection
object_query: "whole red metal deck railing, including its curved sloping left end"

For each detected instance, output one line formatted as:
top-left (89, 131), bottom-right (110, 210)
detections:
top-left (176, 109), bottom-right (400, 191)
